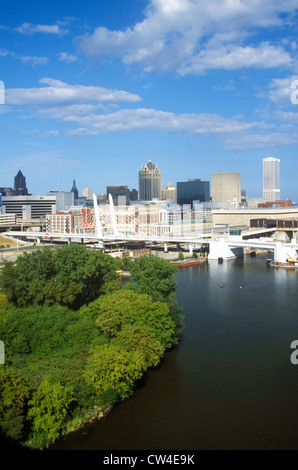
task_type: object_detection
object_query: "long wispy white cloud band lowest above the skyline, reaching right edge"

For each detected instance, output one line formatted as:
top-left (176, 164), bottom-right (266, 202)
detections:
top-left (59, 109), bottom-right (298, 151)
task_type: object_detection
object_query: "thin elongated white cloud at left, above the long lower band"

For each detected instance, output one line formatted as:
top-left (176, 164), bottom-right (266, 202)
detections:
top-left (6, 78), bottom-right (141, 107)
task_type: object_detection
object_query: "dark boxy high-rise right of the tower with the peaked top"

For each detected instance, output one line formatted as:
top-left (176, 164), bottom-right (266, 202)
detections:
top-left (177, 179), bottom-right (210, 205)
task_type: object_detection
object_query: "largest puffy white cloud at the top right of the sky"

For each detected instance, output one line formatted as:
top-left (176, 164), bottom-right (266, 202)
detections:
top-left (79, 0), bottom-right (298, 74)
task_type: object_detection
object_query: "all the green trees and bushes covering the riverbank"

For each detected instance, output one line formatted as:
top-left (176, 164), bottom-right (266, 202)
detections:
top-left (0, 244), bottom-right (183, 449)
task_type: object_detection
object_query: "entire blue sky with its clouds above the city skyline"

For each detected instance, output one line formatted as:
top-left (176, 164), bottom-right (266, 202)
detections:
top-left (0, 0), bottom-right (298, 201)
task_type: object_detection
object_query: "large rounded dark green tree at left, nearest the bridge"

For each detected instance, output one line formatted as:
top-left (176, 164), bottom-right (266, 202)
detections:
top-left (0, 243), bottom-right (119, 309)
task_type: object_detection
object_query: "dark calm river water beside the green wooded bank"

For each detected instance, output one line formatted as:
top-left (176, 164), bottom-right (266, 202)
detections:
top-left (52, 256), bottom-right (298, 450)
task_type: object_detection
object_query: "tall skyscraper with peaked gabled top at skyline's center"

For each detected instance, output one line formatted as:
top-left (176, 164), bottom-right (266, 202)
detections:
top-left (139, 160), bottom-right (161, 201)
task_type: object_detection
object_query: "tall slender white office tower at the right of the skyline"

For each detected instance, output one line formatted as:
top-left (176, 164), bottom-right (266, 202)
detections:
top-left (263, 157), bottom-right (280, 202)
